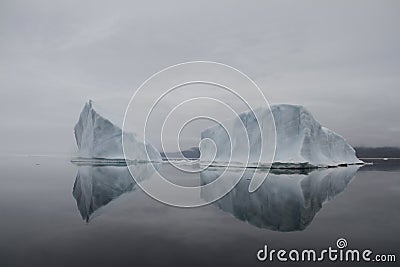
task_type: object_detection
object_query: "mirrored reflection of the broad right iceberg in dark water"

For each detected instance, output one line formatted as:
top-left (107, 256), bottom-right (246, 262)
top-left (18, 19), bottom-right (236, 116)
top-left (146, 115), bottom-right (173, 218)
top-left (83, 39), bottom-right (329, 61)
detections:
top-left (201, 166), bottom-right (359, 231)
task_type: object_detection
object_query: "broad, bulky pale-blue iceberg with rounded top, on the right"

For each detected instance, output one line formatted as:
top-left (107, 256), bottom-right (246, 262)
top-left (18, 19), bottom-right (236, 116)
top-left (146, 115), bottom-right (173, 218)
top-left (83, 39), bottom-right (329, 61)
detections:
top-left (200, 104), bottom-right (362, 168)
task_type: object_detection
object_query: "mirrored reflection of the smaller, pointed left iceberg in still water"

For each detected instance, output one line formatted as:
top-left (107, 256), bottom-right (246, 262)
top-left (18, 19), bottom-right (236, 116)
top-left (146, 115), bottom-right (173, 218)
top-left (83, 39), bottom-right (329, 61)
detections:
top-left (72, 163), bottom-right (154, 222)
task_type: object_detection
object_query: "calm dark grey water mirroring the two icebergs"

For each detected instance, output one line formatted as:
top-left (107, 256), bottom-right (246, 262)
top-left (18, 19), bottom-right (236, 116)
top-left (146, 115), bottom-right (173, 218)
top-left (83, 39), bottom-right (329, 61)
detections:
top-left (0, 157), bottom-right (400, 266)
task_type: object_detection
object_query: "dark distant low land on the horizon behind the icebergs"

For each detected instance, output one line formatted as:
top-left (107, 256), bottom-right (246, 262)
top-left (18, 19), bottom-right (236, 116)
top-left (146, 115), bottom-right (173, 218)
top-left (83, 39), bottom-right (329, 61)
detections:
top-left (161, 147), bottom-right (400, 159)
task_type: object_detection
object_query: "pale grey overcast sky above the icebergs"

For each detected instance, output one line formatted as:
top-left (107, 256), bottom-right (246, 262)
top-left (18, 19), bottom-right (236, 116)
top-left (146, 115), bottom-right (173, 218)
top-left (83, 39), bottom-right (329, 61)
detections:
top-left (0, 0), bottom-right (400, 154)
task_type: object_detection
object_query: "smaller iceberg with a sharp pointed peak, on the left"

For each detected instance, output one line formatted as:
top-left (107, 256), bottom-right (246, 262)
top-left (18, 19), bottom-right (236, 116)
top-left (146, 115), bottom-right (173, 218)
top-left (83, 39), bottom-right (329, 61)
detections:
top-left (74, 100), bottom-right (161, 161)
